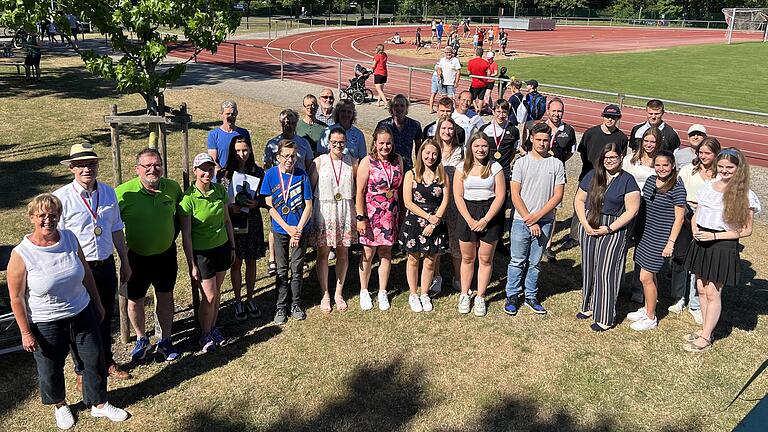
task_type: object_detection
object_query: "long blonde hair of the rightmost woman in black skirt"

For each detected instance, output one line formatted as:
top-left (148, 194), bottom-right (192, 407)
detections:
top-left (715, 147), bottom-right (749, 227)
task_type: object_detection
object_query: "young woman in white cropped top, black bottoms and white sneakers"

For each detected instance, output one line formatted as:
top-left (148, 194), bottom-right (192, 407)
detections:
top-left (453, 132), bottom-right (506, 316)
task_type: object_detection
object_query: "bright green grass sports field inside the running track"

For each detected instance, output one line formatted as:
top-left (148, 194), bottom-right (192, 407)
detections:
top-left (488, 42), bottom-right (768, 123)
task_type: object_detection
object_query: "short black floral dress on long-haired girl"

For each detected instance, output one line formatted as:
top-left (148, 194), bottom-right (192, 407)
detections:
top-left (398, 171), bottom-right (448, 255)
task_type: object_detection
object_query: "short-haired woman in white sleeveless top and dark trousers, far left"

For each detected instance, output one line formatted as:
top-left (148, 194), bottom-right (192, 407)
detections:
top-left (8, 194), bottom-right (128, 429)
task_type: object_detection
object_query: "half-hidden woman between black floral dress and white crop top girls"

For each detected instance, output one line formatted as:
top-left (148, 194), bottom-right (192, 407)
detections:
top-left (431, 117), bottom-right (464, 292)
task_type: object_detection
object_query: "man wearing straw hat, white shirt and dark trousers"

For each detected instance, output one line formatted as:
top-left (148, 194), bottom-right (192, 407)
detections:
top-left (53, 144), bottom-right (131, 388)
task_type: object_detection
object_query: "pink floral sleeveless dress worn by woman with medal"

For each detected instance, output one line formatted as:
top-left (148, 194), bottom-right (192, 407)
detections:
top-left (360, 156), bottom-right (403, 246)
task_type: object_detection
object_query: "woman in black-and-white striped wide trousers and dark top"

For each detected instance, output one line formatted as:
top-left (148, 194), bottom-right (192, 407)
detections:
top-left (573, 144), bottom-right (640, 332)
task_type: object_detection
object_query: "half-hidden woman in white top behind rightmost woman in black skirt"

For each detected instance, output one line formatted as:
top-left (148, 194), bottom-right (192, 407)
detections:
top-left (667, 137), bottom-right (720, 318)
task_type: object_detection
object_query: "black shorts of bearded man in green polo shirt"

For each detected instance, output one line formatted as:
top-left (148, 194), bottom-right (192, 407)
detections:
top-left (127, 242), bottom-right (179, 300)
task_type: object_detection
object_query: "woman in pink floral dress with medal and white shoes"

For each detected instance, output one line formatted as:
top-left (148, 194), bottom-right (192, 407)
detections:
top-left (355, 127), bottom-right (403, 310)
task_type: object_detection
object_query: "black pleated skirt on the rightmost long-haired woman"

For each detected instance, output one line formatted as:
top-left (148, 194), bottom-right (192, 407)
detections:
top-left (685, 227), bottom-right (741, 286)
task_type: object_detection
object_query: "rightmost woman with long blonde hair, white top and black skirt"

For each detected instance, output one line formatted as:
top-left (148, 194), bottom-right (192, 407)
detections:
top-left (683, 147), bottom-right (760, 352)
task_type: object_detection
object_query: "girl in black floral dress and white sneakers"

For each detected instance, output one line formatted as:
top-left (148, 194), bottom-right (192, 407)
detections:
top-left (398, 140), bottom-right (450, 312)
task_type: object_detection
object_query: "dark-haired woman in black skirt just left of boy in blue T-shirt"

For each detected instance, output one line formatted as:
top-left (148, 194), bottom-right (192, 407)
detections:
top-left (217, 136), bottom-right (266, 321)
